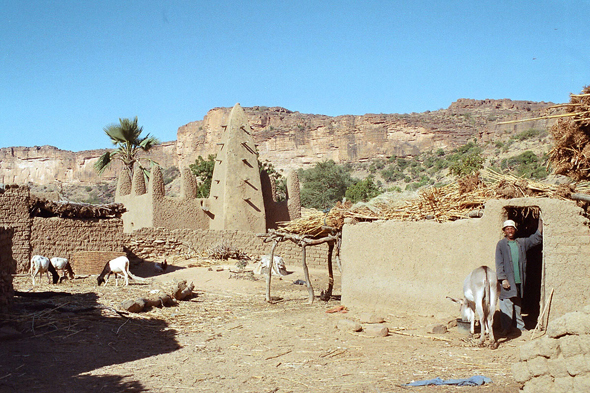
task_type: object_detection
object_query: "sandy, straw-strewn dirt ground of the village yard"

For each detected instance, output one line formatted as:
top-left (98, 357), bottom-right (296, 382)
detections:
top-left (0, 260), bottom-right (529, 393)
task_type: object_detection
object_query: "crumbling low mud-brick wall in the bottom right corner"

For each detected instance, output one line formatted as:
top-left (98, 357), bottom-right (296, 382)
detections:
top-left (512, 306), bottom-right (590, 393)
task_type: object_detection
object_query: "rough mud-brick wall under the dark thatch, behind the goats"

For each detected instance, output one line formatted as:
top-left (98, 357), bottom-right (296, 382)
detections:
top-left (31, 217), bottom-right (123, 259)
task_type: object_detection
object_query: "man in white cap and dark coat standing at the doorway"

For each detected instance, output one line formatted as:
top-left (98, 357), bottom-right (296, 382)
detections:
top-left (496, 218), bottom-right (543, 336)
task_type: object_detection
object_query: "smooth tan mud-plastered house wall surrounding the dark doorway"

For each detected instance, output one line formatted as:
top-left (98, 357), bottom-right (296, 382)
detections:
top-left (341, 198), bottom-right (590, 318)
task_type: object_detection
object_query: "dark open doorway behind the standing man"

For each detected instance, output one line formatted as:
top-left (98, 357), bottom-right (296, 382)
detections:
top-left (505, 206), bottom-right (544, 329)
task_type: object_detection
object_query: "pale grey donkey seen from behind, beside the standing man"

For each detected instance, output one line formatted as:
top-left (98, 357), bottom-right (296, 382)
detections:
top-left (449, 266), bottom-right (500, 349)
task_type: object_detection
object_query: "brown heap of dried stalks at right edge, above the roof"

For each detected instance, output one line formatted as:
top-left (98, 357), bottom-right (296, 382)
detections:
top-left (549, 86), bottom-right (590, 181)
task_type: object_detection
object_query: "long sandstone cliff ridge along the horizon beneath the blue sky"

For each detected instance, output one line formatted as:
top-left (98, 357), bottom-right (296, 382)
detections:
top-left (0, 99), bottom-right (553, 184)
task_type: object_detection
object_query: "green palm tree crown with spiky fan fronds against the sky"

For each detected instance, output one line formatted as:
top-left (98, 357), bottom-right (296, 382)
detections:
top-left (94, 116), bottom-right (160, 178)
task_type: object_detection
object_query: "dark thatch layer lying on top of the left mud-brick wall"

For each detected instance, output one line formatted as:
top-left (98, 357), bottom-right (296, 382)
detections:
top-left (29, 197), bottom-right (126, 219)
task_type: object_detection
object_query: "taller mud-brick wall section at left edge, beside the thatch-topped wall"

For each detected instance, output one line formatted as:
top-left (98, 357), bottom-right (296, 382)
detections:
top-left (0, 185), bottom-right (31, 272)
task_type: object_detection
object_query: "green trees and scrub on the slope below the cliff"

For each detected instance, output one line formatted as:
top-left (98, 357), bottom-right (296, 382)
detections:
top-left (190, 130), bottom-right (548, 210)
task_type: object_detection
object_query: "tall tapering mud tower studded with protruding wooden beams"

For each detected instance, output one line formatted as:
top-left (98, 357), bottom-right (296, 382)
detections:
top-left (209, 104), bottom-right (266, 233)
